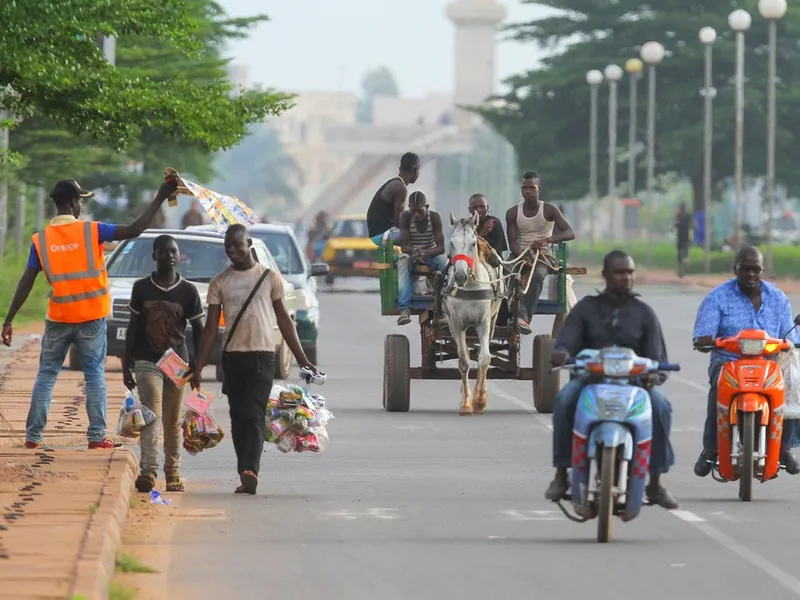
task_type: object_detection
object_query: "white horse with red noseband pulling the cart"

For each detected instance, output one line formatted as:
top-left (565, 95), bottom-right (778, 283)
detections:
top-left (443, 213), bottom-right (503, 415)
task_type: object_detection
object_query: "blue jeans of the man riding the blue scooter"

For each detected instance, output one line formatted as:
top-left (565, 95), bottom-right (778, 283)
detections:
top-left (553, 377), bottom-right (675, 475)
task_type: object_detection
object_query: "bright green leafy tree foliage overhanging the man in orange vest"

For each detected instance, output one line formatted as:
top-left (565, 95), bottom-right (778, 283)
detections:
top-left (0, 0), bottom-right (290, 150)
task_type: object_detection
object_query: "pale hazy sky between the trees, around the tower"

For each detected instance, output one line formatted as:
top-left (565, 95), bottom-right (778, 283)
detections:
top-left (218, 0), bottom-right (542, 97)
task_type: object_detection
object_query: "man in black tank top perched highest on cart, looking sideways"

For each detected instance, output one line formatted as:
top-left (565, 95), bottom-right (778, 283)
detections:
top-left (367, 152), bottom-right (419, 246)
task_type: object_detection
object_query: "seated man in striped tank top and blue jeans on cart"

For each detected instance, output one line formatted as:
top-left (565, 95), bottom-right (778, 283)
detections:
top-left (397, 192), bottom-right (447, 325)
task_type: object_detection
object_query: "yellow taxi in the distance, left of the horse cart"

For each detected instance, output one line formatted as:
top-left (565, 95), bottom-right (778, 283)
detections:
top-left (322, 215), bottom-right (378, 283)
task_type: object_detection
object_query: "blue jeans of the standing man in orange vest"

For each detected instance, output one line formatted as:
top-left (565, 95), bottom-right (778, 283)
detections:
top-left (25, 319), bottom-right (108, 444)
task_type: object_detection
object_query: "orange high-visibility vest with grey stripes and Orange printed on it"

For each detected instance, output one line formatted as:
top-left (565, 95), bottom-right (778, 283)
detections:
top-left (33, 221), bottom-right (111, 323)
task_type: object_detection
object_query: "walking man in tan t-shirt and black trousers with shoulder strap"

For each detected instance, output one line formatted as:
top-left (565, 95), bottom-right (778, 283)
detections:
top-left (192, 225), bottom-right (316, 494)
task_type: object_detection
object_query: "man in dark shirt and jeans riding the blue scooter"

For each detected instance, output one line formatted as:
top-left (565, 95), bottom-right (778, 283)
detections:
top-left (545, 250), bottom-right (678, 509)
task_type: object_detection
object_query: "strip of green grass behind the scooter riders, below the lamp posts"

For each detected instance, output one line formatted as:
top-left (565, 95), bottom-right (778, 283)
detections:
top-left (569, 242), bottom-right (800, 278)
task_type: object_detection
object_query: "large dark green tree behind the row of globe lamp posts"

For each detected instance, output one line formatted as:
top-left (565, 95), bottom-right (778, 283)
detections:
top-left (479, 0), bottom-right (800, 209)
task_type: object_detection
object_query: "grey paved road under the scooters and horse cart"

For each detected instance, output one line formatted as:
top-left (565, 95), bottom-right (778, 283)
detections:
top-left (170, 283), bottom-right (800, 600)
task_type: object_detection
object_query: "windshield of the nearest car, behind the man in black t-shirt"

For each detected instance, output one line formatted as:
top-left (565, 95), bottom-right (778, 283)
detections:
top-left (108, 238), bottom-right (230, 283)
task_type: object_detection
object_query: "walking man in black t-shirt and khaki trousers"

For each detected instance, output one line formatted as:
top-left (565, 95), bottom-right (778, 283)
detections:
top-left (122, 235), bottom-right (204, 493)
